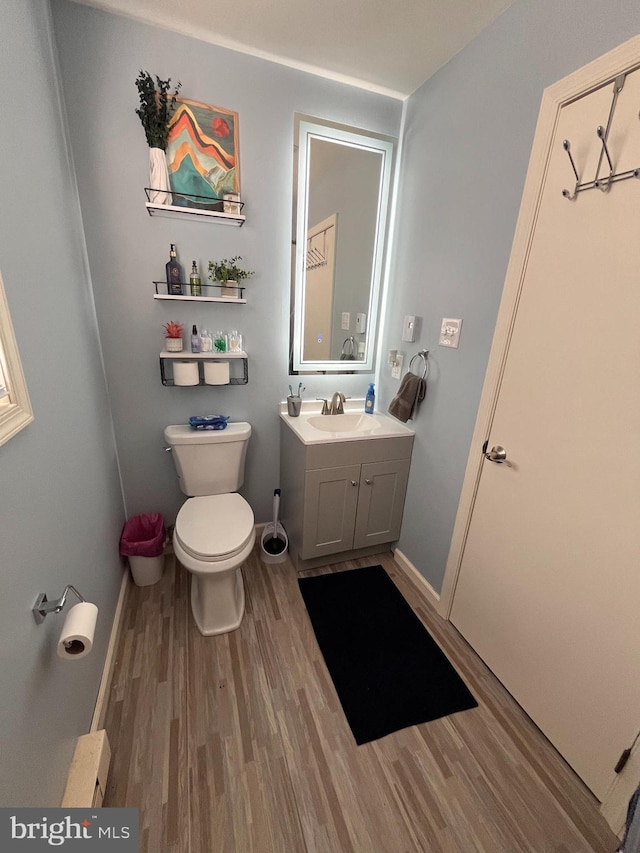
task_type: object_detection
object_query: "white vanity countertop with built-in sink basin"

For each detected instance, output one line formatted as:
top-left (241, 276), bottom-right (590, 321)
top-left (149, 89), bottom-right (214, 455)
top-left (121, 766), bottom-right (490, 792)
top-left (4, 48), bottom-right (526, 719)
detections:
top-left (279, 398), bottom-right (414, 444)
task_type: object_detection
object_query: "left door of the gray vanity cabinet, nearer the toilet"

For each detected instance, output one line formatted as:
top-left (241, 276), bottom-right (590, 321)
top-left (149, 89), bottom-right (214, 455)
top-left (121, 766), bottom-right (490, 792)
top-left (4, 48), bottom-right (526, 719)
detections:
top-left (300, 465), bottom-right (360, 560)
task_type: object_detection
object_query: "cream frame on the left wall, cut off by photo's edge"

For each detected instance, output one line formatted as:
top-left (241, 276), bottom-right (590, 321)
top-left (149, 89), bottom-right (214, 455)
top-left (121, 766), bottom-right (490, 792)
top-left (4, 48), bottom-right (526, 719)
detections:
top-left (0, 273), bottom-right (33, 445)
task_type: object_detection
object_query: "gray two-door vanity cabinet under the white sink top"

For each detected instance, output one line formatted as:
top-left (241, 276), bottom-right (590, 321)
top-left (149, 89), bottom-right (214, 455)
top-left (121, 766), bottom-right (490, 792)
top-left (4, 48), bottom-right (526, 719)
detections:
top-left (280, 425), bottom-right (413, 569)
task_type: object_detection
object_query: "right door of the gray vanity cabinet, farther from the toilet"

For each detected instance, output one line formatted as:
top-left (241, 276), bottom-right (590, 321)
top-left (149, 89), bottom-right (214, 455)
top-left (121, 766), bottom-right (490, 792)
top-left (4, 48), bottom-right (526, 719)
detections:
top-left (353, 459), bottom-right (409, 548)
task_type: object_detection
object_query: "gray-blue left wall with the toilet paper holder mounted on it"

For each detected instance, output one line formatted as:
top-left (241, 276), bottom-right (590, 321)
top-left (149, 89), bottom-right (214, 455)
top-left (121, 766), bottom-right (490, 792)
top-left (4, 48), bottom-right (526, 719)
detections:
top-left (0, 0), bottom-right (124, 806)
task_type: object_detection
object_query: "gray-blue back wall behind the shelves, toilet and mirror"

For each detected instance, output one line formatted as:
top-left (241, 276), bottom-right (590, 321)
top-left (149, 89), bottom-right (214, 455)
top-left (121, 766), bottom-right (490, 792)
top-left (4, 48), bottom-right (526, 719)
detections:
top-left (52, 0), bottom-right (401, 521)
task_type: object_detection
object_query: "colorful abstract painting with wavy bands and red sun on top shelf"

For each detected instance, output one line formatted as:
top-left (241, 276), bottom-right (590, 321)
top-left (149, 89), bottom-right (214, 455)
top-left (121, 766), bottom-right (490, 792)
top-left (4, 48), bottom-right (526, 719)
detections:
top-left (167, 98), bottom-right (240, 210)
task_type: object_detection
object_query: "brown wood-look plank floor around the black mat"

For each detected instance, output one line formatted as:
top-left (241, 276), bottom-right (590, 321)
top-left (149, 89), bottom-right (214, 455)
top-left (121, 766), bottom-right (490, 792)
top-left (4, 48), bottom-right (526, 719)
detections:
top-left (104, 553), bottom-right (618, 853)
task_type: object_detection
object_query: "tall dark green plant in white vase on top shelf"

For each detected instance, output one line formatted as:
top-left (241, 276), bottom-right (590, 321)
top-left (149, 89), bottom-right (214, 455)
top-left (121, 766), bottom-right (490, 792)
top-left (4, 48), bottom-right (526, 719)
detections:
top-left (136, 71), bottom-right (182, 204)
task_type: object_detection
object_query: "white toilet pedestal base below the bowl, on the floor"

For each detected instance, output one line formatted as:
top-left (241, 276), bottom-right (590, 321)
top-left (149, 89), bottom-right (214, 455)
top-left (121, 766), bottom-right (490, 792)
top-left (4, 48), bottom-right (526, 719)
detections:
top-left (191, 567), bottom-right (244, 637)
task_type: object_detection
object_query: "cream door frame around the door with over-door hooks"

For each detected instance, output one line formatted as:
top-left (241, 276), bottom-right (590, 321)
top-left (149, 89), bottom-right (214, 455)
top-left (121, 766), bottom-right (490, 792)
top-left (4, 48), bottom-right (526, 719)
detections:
top-left (437, 36), bottom-right (640, 831)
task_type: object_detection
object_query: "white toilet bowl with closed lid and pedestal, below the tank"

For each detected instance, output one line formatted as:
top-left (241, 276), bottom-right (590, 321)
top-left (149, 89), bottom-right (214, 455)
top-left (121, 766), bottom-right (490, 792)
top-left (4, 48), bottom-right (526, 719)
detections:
top-left (173, 493), bottom-right (256, 636)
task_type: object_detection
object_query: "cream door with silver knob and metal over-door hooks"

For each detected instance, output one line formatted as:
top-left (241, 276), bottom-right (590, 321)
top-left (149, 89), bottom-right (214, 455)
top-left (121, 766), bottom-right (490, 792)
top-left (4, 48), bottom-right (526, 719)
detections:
top-left (451, 56), bottom-right (640, 799)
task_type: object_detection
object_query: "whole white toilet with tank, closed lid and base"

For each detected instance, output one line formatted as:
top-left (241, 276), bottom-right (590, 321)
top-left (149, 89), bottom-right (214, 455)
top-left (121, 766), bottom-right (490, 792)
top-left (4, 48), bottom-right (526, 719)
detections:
top-left (164, 423), bottom-right (256, 636)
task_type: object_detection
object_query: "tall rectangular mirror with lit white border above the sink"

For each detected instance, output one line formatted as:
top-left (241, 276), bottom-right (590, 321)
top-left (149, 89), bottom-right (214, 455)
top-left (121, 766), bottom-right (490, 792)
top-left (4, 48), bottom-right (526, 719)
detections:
top-left (290, 115), bottom-right (395, 373)
